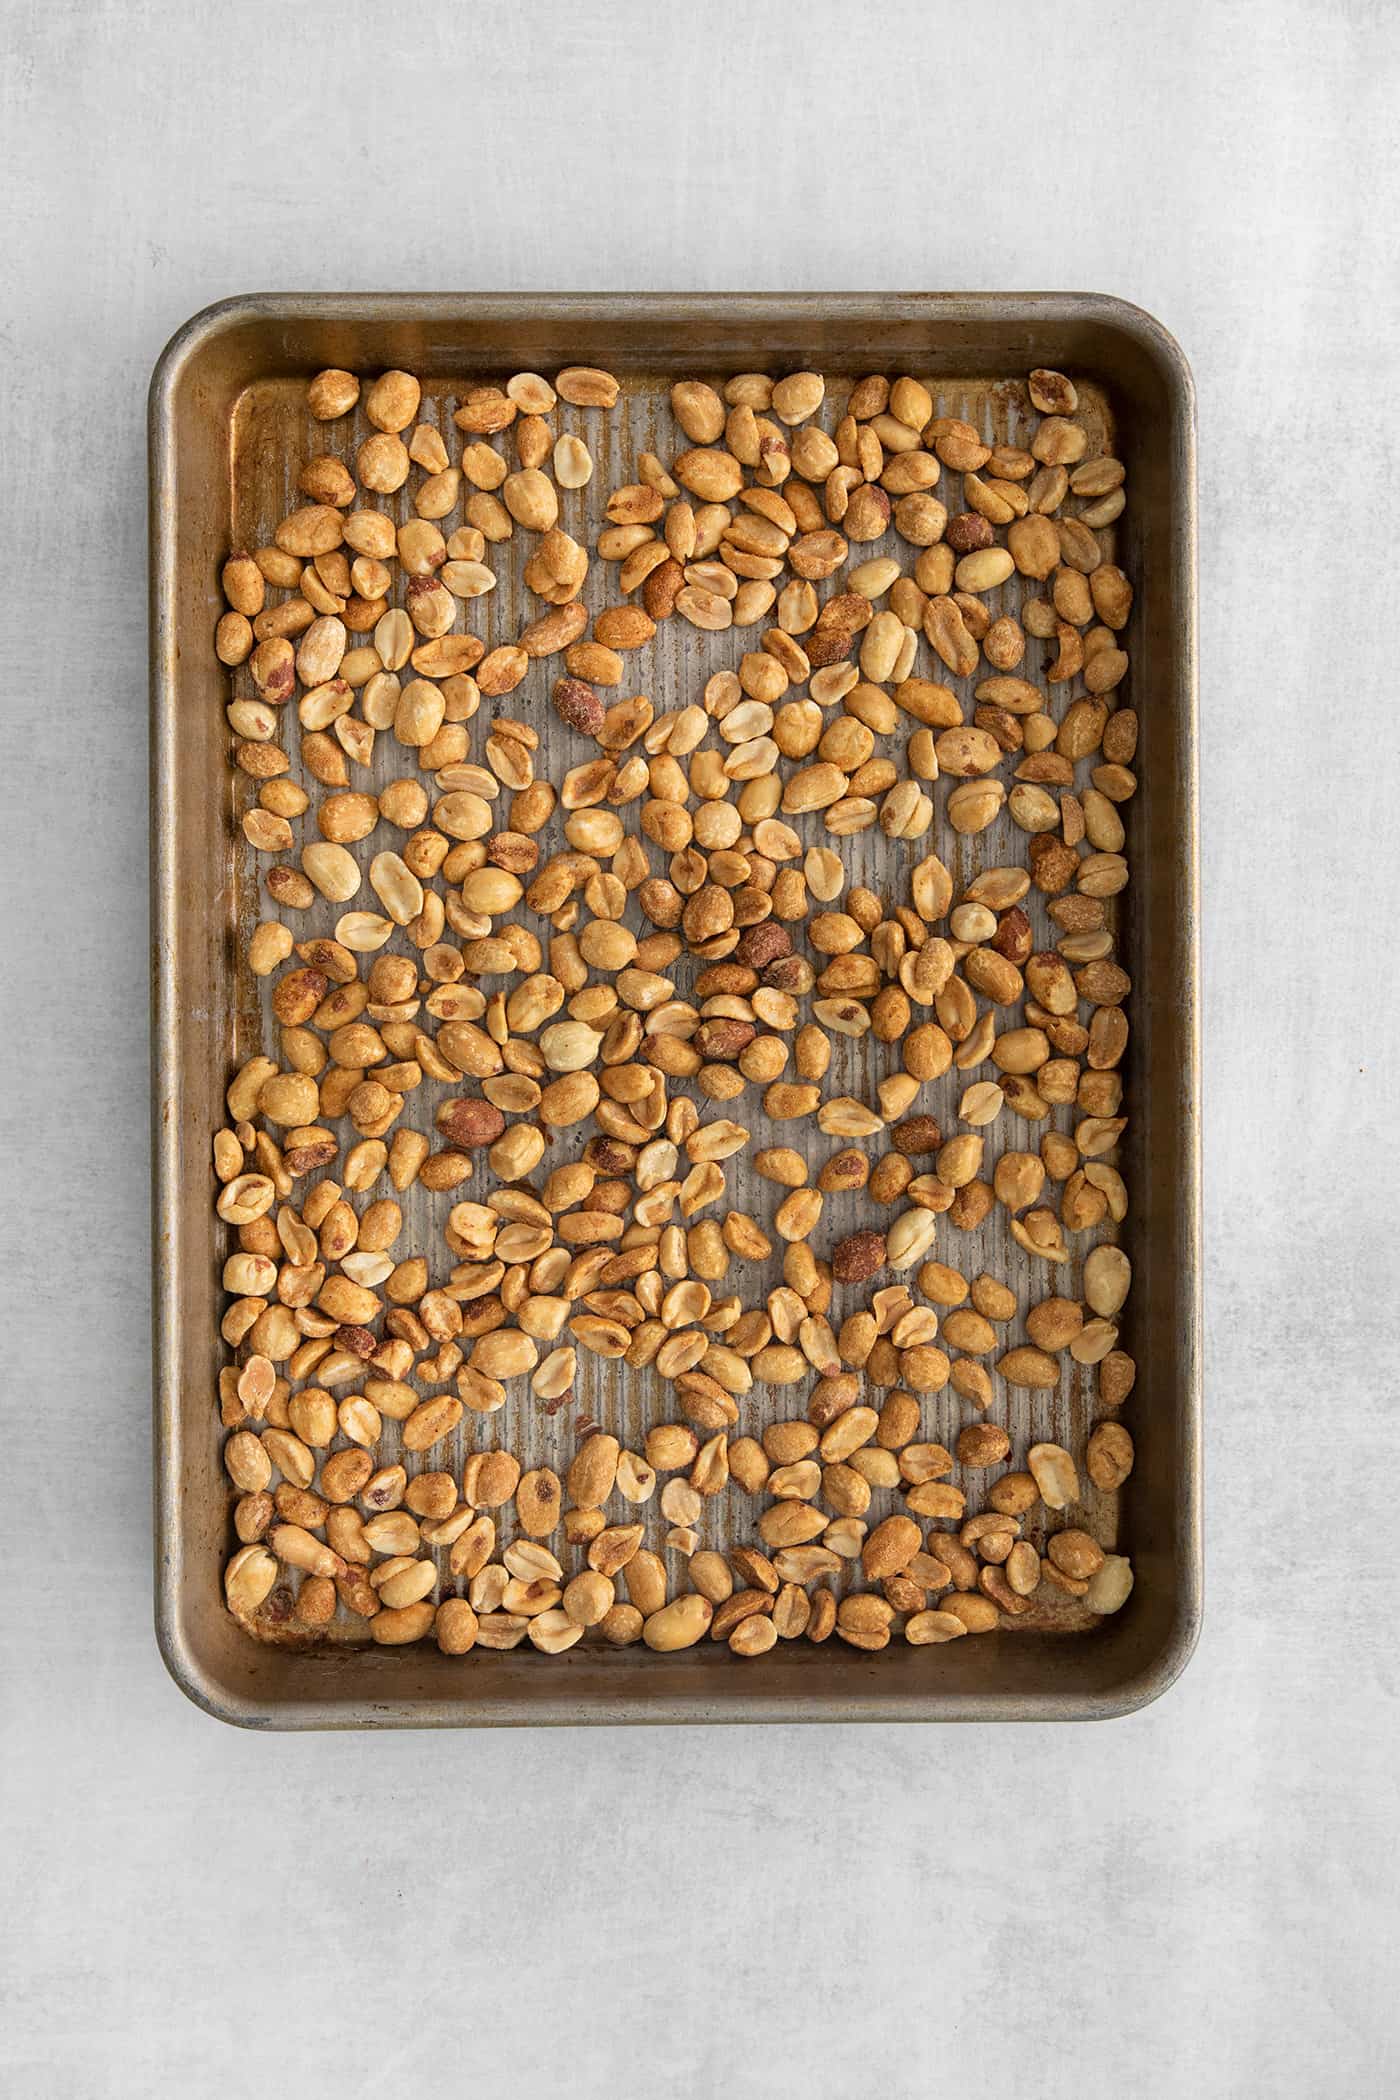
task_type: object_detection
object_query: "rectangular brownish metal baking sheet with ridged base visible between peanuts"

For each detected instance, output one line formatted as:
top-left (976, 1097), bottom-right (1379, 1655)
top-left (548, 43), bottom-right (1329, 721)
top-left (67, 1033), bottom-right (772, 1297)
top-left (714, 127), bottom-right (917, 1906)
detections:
top-left (153, 296), bottom-right (1199, 1724)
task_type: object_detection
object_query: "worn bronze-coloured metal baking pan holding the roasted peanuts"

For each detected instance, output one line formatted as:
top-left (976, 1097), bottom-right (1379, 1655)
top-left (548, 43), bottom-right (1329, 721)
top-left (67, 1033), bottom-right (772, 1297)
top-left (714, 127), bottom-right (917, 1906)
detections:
top-left (149, 292), bottom-right (1201, 1728)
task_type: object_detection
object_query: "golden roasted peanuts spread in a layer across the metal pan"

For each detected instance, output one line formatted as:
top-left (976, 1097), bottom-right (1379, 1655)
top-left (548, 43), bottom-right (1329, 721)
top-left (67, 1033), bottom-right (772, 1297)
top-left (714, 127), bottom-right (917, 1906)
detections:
top-left (214, 352), bottom-right (1138, 1657)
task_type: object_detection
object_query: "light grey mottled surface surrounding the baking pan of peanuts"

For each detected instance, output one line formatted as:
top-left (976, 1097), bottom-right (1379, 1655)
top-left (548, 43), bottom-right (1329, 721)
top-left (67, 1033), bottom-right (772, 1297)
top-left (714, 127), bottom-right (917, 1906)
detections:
top-left (0, 0), bottom-right (1400, 2100)
